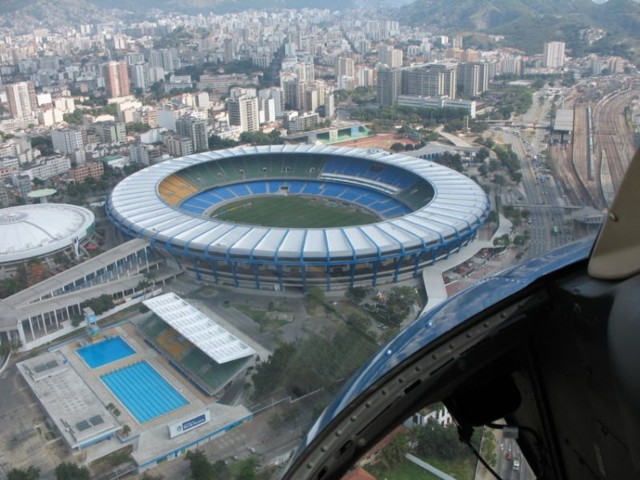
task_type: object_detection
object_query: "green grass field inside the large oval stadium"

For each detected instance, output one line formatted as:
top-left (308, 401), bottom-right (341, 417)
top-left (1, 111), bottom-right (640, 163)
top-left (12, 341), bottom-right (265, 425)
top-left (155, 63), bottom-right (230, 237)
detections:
top-left (211, 196), bottom-right (379, 228)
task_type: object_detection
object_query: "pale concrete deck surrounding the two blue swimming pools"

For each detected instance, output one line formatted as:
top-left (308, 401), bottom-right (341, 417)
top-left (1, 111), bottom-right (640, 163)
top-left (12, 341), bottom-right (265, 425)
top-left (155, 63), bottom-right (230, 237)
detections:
top-left (19, 323), bottom-right (251, 465)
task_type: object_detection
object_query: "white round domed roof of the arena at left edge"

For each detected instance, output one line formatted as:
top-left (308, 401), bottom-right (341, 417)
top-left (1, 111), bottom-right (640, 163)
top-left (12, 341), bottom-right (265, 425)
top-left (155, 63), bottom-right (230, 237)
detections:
top-left (0, 203), bottom-right (95, 263)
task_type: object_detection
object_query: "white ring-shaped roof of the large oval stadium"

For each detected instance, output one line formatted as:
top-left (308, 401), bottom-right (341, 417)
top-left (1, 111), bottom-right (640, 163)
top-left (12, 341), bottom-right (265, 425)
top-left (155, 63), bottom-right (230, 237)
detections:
top-left (108, 145), bottom-right (489, 262)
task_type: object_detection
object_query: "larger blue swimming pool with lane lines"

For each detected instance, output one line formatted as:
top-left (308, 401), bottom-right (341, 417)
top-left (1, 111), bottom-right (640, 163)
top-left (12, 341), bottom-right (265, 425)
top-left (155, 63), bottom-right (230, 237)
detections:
top-left (101, 362), bottom-right (189, 423)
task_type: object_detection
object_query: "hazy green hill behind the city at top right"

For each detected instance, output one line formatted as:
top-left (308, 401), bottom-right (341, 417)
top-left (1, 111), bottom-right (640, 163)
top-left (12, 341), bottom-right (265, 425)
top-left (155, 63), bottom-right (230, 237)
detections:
top-left (397, 0), bottom-right (640, 57)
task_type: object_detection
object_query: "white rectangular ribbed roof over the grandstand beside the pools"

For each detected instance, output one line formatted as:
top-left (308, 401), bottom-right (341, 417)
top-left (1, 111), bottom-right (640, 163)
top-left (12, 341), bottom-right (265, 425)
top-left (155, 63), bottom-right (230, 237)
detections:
top-left (142, 293), bottom-right (256, 363)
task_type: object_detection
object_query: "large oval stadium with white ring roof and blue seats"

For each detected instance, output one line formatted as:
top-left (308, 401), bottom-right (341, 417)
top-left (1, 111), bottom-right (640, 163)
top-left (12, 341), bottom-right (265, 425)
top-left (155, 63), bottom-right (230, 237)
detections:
top-left (107, 145), bottom-right (489, 291)
